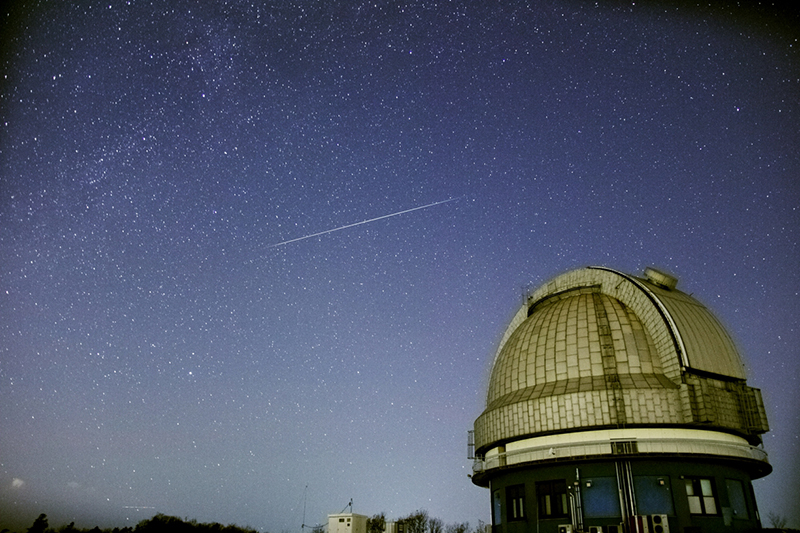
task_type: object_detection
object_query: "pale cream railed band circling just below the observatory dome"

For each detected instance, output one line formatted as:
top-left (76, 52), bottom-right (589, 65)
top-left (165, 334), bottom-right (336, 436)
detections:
top-left (470, 438), bottom-right (769, 473)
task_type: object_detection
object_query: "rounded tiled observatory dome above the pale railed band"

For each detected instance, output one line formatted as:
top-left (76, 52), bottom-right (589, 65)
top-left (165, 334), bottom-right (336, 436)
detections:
top-left (474, 267), bottom-right (768, 482)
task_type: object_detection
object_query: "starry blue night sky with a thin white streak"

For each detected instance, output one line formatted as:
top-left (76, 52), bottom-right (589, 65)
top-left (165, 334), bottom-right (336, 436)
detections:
top-left (0, 0), bottom-right (800, 533)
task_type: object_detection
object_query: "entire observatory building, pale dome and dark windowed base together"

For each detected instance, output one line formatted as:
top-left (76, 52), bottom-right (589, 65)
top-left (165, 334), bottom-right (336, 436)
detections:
top-left (470, 267), bottom-right (772, 533)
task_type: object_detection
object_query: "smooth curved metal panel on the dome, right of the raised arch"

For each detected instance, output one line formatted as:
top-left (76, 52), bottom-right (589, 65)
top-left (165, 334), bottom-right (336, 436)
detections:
top-left (645, 282), bottom-right (747, 379)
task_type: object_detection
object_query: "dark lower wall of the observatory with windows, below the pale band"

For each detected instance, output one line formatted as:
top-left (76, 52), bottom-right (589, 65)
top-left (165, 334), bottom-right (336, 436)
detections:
top-left (489, 458), bottom-right (761, 533)
